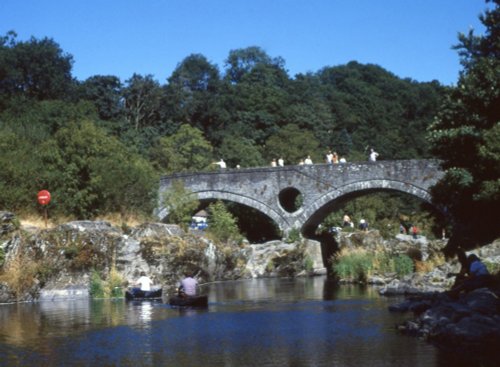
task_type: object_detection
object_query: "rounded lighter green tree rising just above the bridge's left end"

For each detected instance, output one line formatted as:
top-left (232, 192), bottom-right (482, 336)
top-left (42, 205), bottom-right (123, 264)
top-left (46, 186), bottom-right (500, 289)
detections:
top-left (150, 124), bottom-right (213, 173)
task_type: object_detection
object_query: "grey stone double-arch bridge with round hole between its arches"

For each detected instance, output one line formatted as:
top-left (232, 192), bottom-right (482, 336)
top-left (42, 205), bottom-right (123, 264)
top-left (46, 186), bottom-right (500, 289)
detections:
top-left (156, 160), bottom-right (444, 233)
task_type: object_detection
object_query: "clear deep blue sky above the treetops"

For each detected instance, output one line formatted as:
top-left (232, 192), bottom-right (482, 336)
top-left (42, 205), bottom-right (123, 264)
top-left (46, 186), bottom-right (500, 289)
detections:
top-left (0, 0), bottom-right (491, 85)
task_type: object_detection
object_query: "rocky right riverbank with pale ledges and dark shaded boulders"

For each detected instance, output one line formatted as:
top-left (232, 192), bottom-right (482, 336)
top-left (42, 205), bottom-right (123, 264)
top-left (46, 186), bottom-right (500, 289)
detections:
top-left (332, 227), bottom-right (500, 357)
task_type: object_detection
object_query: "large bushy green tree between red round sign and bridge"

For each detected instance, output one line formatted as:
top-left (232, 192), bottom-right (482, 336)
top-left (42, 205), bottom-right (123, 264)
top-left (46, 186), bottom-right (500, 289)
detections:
top-left (39, 121), bottom-right (158, 219)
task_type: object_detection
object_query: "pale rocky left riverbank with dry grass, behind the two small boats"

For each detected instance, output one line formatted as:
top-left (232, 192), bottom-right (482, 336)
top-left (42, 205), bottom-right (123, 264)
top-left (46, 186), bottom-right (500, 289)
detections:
top-left (0, 212), bottom-right (326, 303)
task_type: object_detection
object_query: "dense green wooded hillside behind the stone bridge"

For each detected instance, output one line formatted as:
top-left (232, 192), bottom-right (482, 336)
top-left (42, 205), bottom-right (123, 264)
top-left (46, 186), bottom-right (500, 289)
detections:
top-left (0, 20), bottom-right (472, 234)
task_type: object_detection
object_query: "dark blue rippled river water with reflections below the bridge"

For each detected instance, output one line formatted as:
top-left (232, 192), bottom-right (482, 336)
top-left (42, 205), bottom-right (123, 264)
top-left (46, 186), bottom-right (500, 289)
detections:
top-left (0, 277), bottom-right (494, 367)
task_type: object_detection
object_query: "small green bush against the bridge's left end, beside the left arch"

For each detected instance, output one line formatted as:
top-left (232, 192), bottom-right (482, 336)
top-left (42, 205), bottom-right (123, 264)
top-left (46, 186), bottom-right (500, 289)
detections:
top-left (162, 181), bottom-right (200, 230)
